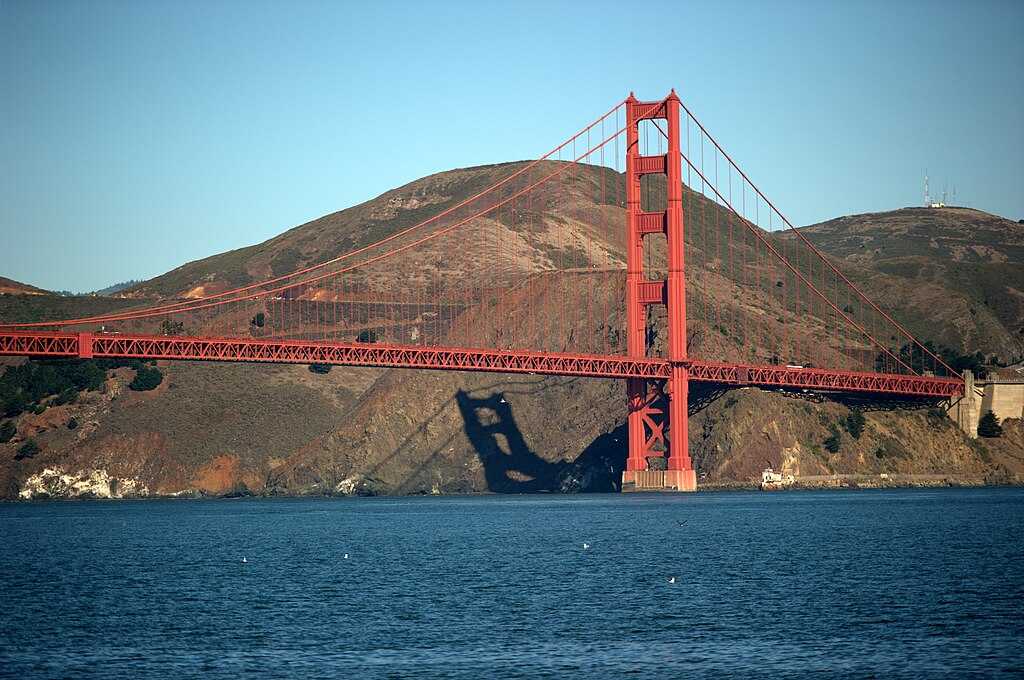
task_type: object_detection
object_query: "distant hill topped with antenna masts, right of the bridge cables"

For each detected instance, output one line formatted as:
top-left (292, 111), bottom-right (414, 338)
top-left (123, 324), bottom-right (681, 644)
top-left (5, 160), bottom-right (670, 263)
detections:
top-left (782, 208), bottom-right (1024, 364)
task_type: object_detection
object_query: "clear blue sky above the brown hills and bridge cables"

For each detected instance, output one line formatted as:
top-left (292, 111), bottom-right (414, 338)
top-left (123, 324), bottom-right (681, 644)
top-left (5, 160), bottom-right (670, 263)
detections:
top-left (0, 0), bottom-right (1024, 291)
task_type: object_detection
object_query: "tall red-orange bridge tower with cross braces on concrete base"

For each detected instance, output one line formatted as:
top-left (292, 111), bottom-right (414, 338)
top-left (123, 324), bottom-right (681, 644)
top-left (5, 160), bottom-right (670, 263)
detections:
top-left (623, 90), bottom-right (696, 491)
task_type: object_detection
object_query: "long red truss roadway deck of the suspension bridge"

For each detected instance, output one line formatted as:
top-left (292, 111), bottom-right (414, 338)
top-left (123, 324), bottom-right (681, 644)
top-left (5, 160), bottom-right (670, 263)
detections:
top-left (0, 331), bottom-right (964, 398)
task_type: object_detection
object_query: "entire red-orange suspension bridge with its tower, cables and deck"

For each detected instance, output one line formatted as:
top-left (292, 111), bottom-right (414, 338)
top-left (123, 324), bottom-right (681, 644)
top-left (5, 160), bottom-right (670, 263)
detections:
top-left (0, 91), bottom-right (964, 491)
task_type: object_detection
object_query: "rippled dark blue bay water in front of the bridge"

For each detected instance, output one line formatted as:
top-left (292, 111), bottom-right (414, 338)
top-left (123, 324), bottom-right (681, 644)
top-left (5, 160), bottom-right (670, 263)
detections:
top-left (0, 490), bottom-right (1024, 678)
